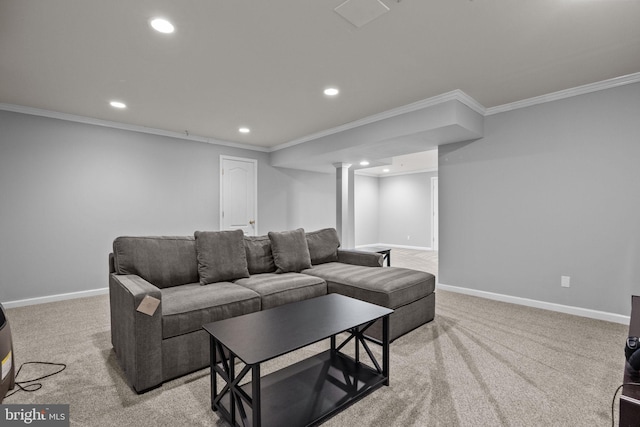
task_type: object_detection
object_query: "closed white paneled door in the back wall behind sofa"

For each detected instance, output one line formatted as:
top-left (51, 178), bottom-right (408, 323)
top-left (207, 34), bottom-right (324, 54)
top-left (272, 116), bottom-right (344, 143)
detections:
top-left (220, 156), bottom-right (258, 236)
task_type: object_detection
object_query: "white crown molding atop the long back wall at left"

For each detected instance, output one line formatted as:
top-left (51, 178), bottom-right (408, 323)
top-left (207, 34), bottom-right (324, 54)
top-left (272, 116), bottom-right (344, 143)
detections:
top-left (0, 103), bottom-right (269, 153)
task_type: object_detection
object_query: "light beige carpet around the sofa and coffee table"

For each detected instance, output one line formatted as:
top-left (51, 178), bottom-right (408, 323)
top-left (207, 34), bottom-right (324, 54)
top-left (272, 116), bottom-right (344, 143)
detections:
top-left (4, 249), bottom-right (627, 427)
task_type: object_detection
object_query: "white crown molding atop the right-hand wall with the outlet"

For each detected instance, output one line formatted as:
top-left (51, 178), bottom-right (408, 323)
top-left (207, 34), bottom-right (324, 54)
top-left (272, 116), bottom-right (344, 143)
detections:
top-left (485, 73), bottom-right (640, 116)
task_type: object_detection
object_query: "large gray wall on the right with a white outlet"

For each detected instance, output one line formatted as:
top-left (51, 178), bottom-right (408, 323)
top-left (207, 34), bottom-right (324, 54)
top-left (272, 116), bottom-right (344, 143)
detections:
top-left (439, 83), bottom-right (640, 315)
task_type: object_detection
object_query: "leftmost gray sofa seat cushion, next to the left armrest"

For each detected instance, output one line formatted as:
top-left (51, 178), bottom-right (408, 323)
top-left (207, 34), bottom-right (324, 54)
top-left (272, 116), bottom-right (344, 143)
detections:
top-left (162, 282), bottom-right (260, 338)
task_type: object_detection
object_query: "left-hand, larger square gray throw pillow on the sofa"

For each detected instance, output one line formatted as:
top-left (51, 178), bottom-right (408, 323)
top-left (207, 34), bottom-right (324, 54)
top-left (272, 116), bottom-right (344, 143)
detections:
top-left (194, 230), bottom-right (249, 285)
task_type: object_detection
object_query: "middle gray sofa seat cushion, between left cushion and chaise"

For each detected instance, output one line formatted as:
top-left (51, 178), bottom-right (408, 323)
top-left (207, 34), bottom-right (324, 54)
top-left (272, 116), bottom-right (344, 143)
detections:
top-left (235, 273), bottom-right (327, 310)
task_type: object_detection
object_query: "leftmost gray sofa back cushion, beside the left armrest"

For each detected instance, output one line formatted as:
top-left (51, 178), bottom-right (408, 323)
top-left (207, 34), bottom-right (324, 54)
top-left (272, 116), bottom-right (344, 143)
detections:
top-left (113, 236), bottom-right (198, 288)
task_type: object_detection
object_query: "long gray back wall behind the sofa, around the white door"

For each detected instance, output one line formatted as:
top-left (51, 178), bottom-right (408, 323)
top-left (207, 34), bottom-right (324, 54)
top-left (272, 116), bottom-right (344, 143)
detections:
top-left (0, 111), bottom-right (335, 302)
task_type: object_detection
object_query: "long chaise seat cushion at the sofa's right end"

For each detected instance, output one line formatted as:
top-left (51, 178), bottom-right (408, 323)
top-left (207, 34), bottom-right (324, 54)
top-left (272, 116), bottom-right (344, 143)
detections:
top-left (302, 262), bottom-right (435, 309)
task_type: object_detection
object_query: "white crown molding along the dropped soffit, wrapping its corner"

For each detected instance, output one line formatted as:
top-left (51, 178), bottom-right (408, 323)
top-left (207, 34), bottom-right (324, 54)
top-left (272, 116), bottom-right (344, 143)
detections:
top-left (270, 89), bottom-right (485, 152)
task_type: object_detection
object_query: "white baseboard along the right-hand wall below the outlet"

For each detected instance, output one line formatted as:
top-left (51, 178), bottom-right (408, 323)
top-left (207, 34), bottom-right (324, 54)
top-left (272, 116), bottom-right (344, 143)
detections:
top-left (436, 283), bottom-right (630, 325)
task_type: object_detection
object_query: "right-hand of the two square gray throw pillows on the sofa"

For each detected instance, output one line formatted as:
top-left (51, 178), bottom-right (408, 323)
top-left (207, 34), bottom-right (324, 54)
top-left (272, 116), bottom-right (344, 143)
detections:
top-left (269, 228), bottom-right (311, 273)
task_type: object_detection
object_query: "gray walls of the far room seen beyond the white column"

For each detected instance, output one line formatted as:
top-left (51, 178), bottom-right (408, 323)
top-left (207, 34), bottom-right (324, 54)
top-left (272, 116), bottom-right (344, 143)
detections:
top-left (355, 172), bottom-right (438, 248)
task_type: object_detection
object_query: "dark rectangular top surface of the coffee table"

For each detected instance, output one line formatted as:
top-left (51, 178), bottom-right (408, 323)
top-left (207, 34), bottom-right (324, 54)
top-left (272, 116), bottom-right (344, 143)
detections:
top-left (203, 294), bottom-right (393, 365)
